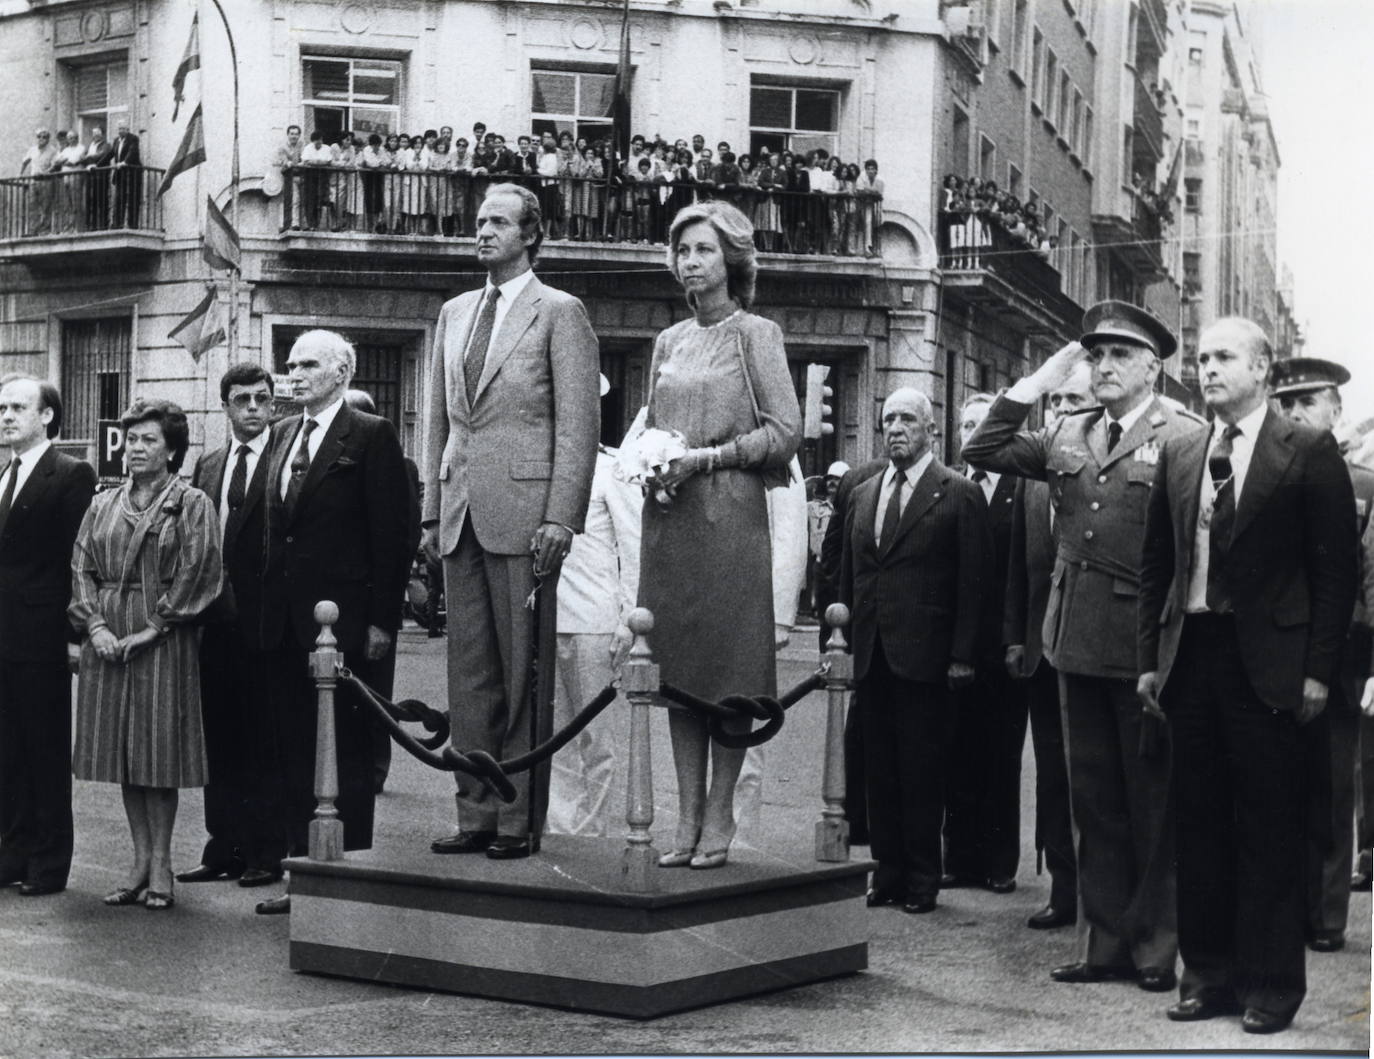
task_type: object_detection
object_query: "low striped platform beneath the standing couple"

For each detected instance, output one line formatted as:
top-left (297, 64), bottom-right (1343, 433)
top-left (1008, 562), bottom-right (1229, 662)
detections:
top-left (287, 835), bottom-right (872, 1018)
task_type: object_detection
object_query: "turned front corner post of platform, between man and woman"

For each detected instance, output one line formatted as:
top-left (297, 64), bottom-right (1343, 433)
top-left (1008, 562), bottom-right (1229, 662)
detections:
top-left (620, 607), bottom-right (658, 893)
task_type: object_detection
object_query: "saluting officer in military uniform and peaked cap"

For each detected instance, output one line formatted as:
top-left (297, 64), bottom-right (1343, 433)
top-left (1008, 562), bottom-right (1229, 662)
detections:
top-left (963, 301), bottom-right (1202, 992)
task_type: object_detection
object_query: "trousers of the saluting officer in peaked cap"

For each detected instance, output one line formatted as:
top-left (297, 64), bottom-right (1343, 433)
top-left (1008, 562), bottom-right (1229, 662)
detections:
top-left (1059, 672), bottom-right (1178, 970)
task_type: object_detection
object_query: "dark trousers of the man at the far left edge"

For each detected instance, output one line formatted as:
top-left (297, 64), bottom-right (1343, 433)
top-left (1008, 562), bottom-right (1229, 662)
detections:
top-left (0, 659), bottom-right (71, 886)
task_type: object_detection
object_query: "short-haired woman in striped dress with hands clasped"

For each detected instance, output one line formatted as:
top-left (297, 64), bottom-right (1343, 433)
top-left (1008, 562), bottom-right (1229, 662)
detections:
top-left (67, 400), bottom-right (223, 909)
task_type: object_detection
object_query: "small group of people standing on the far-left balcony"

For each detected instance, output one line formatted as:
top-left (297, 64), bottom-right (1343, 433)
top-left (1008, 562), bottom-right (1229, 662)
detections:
top-left (5, 121), bottom-right (144, 236)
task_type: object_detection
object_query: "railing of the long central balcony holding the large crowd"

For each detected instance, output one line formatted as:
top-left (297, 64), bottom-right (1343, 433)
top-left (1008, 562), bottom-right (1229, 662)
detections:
top-left (282, 166), bottom-right (882, 257)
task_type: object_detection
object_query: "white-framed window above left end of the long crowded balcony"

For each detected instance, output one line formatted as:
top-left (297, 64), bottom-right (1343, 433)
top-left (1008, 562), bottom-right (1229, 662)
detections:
top-left (301, 55), bottom-right (401, 141)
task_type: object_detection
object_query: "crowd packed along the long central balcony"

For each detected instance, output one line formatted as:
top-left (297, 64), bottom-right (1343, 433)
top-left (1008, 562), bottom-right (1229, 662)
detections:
top-left (273, 122), bottom-right (883, 257)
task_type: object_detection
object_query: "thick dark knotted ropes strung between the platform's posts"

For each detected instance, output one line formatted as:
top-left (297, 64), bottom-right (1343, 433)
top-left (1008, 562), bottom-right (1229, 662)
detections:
top-left (335, 663), bottom-right (830, 802)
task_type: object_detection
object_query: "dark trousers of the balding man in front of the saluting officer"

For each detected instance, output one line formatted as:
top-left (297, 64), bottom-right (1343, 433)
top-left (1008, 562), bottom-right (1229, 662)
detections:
top-left (1164, 615), bottom-right (1307, 1016)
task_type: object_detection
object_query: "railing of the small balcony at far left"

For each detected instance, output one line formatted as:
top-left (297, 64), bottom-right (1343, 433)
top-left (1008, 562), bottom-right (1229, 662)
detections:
top-left (0, 166), bottom-right (164, 240)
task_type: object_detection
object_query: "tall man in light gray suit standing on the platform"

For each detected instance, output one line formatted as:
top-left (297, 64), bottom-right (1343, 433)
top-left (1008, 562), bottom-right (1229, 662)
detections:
top-left (422, 184), bottom-right (600, 860)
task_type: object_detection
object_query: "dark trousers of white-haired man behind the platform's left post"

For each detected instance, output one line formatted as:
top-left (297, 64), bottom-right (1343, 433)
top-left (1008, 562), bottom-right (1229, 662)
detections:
top-left (265, 626), bottom-right (375, 856)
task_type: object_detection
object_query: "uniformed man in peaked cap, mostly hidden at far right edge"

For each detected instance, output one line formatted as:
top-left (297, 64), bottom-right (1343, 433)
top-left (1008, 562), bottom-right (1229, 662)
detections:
top-left (1270, 357), bottom-right (1374, 952)
